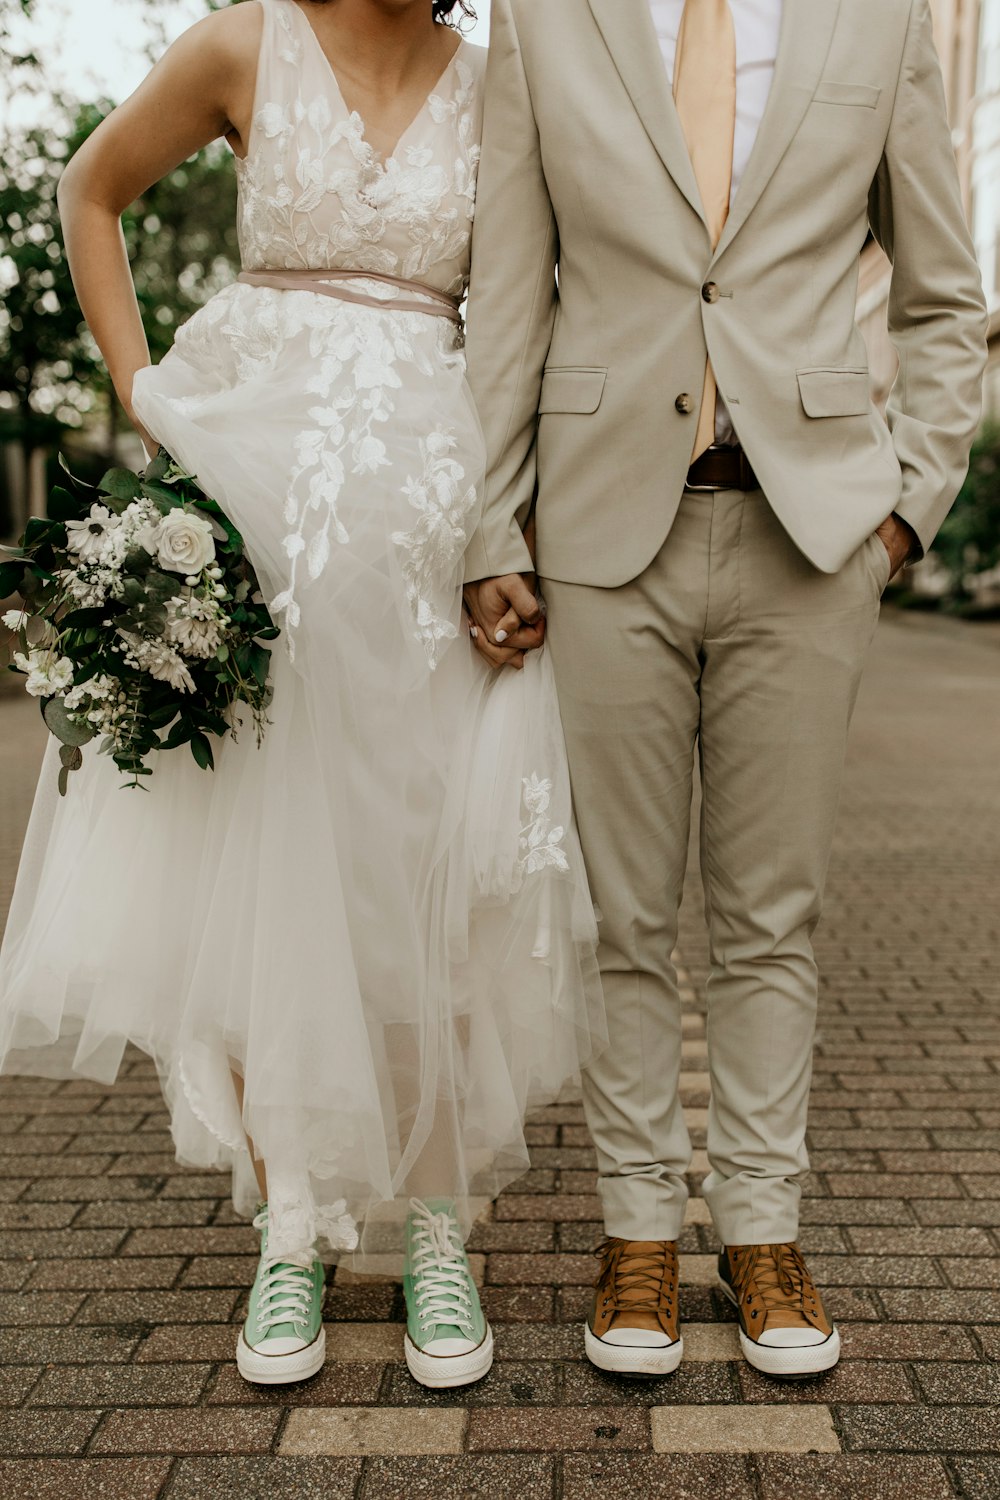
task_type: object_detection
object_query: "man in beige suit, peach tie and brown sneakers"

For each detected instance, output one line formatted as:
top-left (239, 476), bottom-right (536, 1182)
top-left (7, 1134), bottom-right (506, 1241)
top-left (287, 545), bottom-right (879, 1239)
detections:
top-left (466, 0), bottom-right (985, 1377)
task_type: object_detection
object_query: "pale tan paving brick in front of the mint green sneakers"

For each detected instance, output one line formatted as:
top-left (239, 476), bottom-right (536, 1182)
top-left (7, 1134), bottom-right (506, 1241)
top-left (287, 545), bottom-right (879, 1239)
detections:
top-left (277, 1407), bottom-right (468, 1454)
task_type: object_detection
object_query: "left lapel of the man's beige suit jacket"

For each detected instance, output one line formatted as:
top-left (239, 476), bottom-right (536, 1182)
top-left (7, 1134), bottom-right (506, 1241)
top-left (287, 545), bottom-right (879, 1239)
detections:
top-left (589, 0), bottom-right (707, 222)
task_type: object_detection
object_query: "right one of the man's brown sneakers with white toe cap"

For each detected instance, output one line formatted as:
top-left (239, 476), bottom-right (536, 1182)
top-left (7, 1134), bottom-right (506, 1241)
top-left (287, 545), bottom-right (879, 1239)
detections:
top-left (718, 1245), bottom-right (840, 1380)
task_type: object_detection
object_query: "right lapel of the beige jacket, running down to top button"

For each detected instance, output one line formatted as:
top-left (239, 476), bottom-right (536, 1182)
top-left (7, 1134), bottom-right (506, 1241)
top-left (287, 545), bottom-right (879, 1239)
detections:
top-left (715, 0), bottom-right (845, 257)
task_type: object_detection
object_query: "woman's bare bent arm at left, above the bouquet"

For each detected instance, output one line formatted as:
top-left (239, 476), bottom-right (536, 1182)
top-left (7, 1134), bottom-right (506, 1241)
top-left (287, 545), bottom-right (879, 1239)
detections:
top-left (58, 5), bottom-right (261, 452)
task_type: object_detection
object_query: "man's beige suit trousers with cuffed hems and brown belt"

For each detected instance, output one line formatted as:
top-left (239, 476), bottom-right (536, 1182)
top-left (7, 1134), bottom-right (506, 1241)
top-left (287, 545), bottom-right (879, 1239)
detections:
top-left (544, 491), bottom-right (889, 1245)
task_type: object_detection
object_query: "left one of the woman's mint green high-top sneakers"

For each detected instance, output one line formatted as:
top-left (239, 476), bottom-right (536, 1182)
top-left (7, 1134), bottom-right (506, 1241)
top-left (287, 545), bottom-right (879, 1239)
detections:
top-left (235, 1203), bottom-right (327, 1386)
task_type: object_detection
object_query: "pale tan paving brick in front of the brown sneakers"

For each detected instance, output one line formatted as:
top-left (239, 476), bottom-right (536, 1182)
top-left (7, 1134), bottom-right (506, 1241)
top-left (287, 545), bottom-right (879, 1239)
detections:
top-left (649, 1406), bottom-right (840, 1454)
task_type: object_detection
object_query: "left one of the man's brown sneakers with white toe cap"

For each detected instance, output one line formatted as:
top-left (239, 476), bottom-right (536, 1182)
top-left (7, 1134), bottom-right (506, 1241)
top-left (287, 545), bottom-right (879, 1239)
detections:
top-left (583, 1239), bottom-right (684, 1376)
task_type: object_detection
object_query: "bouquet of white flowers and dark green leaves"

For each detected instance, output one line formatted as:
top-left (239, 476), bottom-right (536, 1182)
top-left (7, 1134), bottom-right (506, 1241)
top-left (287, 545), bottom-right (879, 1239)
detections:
top-left (0, 450), bottom-right (279, 794)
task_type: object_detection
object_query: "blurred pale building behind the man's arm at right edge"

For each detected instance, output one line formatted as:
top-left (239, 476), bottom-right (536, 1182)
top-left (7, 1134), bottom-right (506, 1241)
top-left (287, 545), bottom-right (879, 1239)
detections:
top-left (858, 0), bottom-right (1000, 419)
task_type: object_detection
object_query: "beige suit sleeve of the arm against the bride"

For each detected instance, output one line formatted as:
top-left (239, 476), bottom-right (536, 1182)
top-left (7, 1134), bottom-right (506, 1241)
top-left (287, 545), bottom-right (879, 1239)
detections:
top-left (465, 0), bottom-right (556, 581)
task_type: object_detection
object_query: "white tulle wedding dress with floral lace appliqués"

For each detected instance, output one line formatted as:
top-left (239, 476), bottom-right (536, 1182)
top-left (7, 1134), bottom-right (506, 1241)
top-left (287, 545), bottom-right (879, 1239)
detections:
top-left (0, 0), bottom-right (603, 1253)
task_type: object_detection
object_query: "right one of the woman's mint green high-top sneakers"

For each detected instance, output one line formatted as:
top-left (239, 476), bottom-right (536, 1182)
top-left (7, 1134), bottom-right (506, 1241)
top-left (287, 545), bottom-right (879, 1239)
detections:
top-left (403, 1199), bottom-right (493, 1391)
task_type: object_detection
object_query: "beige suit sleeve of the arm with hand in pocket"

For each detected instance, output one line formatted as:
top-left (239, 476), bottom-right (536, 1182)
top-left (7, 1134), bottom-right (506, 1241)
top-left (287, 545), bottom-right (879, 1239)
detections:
top-left (870, 0), bottom-right (987, 552)
